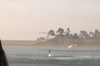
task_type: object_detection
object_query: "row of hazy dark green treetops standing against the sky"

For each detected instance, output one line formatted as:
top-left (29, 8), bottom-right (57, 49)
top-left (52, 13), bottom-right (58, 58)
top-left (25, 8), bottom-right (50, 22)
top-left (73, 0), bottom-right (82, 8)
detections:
top-left (48, 28), bottom-right (100, 40)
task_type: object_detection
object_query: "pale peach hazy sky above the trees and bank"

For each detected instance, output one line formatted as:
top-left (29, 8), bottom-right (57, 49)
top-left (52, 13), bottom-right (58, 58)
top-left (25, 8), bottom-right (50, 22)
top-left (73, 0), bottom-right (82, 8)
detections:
top-left (0, 0), bottom-right (100, 40)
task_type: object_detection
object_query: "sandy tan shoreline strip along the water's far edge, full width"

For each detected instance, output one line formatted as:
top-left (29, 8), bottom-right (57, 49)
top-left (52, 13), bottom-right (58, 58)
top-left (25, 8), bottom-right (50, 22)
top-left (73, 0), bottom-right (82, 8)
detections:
top-left (2, 40), bottom-right (100, 49)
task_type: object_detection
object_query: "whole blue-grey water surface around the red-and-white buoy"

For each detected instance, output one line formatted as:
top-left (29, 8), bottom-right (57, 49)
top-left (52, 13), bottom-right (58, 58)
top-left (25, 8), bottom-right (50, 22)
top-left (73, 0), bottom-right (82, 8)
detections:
top-left (3, 46), bottom-right (100, 66)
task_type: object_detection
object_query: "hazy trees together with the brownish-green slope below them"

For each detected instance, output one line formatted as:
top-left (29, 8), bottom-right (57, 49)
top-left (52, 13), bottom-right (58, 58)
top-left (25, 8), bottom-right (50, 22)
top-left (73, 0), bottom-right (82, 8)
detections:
top-left (35, 28), bottom-right (100, 47)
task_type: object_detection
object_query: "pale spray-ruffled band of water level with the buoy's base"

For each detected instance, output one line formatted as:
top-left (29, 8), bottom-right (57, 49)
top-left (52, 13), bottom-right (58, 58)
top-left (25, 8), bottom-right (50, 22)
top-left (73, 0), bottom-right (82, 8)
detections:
top-left (7, 54), bottom-right (100, 60)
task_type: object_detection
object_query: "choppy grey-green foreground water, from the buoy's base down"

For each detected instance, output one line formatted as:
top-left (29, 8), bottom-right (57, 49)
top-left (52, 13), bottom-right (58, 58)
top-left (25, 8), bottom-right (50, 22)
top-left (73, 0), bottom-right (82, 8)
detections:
top-left (7, 54), bottom-right (100, 66)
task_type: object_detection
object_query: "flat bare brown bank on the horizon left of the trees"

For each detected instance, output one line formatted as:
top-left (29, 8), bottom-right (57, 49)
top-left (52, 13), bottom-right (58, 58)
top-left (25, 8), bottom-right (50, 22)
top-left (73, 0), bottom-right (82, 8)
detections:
top-left (2, 40), bottom-right (38, 46)
